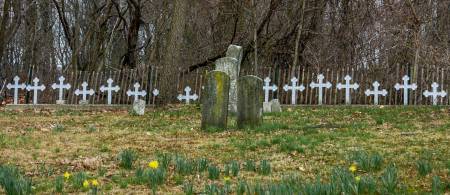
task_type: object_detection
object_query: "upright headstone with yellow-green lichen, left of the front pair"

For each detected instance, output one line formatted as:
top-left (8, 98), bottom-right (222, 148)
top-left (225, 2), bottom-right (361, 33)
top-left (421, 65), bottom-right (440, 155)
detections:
top-left (201, 71), bottom-right (230, 130)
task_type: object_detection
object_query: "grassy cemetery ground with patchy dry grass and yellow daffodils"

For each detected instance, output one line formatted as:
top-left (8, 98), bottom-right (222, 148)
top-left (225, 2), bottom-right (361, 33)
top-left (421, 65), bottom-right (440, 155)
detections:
top-left (0, 105), bottom-right (450, 194)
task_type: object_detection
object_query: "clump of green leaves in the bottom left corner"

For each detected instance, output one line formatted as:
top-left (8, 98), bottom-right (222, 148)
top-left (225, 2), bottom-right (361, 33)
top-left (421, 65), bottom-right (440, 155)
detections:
top-left (0, 166), bottom-right (32, 195)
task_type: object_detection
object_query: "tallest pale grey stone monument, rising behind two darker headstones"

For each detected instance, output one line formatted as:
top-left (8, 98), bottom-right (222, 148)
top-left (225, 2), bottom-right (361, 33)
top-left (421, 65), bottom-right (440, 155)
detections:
top-left (215, 45), bottom-right (243, 113)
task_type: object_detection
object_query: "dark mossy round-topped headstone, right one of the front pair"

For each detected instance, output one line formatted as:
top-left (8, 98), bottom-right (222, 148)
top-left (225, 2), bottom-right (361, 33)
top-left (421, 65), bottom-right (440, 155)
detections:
top-left (237, 75), bottom-right (264, 129)
